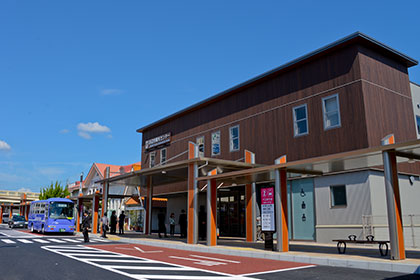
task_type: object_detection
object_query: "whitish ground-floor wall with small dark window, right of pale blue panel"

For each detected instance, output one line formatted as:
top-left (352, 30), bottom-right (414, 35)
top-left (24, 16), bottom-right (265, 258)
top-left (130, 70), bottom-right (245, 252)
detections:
top-left (314, 171), bottom-right (372, 243)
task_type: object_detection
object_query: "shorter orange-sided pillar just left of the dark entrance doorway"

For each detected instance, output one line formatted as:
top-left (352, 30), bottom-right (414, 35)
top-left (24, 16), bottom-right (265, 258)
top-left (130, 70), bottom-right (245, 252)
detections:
top-left (207, 169), bottom-right (217, 246)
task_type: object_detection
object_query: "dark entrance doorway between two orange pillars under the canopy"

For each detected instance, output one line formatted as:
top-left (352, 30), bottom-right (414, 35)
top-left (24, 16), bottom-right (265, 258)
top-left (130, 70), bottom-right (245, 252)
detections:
top-left (217, 187), bottom-right (245, 237)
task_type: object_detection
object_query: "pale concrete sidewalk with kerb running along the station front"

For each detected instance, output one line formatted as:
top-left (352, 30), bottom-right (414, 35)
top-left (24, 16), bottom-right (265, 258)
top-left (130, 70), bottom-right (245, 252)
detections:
top-left (79, 233), bottom-right (420, 274)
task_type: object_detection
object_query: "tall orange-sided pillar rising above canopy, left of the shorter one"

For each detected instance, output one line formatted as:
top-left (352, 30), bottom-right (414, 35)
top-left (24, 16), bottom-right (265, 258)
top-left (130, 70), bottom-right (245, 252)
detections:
top-left (187, 142), bottom-right (198, 244)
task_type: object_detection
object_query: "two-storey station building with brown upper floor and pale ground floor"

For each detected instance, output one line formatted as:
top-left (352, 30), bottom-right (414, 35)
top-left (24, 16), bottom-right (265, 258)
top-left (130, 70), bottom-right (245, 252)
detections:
top-left (102, 32), bottom-right (420, 260)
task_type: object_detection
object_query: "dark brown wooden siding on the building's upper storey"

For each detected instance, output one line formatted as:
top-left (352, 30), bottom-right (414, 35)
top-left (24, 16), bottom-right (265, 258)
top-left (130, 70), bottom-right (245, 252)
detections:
top-left (142, 42), bottom-right (415, 174)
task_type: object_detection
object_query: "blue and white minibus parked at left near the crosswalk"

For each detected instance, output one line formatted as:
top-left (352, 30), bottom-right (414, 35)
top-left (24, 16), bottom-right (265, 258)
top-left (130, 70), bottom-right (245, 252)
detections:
top-left (28, 198), bottom-right (75, 233)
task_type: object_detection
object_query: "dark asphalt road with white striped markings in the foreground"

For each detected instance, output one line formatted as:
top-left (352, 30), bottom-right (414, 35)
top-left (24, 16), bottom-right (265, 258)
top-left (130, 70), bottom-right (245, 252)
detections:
top-left (0, 225), bottom-right (420, 280)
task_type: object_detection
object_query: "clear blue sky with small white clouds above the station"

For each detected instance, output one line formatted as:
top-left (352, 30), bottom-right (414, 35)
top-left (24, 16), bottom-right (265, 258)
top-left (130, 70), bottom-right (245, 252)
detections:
top-left (0, 0), bottom-right (420, 191)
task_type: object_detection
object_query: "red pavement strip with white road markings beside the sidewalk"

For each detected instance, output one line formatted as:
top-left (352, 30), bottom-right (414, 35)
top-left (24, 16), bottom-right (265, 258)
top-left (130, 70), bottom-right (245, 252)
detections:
top-left (89, 244), bottom-right (314, 275)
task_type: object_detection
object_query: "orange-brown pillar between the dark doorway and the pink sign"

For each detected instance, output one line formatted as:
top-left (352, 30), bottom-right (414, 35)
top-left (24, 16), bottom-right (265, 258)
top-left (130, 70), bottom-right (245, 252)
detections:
top-left (245, 150), bottom-right (257, 242)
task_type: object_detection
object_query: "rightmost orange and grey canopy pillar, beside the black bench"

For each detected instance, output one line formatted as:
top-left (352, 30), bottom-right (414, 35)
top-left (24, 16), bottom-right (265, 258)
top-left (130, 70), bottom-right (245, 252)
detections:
top-left (382, 134), bottom-right (405, 260)
